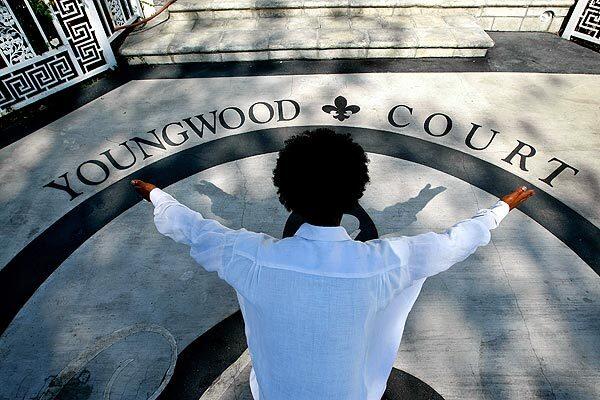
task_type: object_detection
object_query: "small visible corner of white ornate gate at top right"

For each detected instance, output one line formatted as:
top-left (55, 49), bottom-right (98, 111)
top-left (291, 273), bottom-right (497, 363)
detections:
top-left (562, 0), bottom-right (600, 45)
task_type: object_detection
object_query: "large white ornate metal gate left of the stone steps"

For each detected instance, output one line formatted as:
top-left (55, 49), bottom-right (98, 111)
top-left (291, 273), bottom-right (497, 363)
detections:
top-left (0, 0), bottom-right (141, 115)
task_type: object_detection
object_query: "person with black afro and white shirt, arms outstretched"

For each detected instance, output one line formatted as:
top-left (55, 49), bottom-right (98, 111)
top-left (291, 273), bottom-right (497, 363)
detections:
top-left (132, 129), bottom-right (533, 400)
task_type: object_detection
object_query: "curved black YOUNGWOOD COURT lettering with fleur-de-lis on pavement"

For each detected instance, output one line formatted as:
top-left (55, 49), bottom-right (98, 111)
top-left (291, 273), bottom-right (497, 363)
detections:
top-left (44, 96), bottom-right (579, 200)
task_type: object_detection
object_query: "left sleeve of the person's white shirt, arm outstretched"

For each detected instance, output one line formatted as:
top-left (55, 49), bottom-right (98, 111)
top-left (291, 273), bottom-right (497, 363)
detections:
top-left (150, 188), bottom-right (240, 279)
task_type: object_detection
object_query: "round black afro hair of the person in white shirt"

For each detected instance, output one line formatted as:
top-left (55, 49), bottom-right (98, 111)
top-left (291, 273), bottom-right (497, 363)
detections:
top-left (273, 128), bottom-right (369, 225)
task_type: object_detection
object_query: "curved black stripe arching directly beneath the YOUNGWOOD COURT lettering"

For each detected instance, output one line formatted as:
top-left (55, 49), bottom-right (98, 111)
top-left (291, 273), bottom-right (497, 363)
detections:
top-left (0, 126), bottom-right (600, 332)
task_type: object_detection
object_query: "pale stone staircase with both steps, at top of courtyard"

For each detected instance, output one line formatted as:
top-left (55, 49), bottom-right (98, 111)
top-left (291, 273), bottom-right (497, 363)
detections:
top-left (120, 0), bottom-right (573, 64)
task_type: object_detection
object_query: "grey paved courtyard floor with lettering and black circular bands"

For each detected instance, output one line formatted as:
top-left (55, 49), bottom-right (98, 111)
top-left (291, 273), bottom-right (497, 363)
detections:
top-left (0, 33), bottom-right (600, 400)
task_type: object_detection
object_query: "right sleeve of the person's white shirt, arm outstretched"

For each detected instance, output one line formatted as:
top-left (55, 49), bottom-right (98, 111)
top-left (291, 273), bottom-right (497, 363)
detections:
top-left (381, 201), bottom-right (509, 304)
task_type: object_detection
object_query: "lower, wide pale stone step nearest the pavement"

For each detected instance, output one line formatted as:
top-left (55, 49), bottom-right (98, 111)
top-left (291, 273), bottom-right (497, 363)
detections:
top-left (120, 15), bottom-right (494, 64)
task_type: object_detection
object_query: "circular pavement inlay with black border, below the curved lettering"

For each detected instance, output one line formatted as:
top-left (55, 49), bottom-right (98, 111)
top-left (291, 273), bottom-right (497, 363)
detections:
top-left (0, 127), bottom-right (600, 400)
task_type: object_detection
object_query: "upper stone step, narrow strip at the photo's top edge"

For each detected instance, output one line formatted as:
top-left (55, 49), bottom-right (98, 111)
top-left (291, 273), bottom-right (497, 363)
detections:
top-left (169, 0), bottom-right (575, 33)
